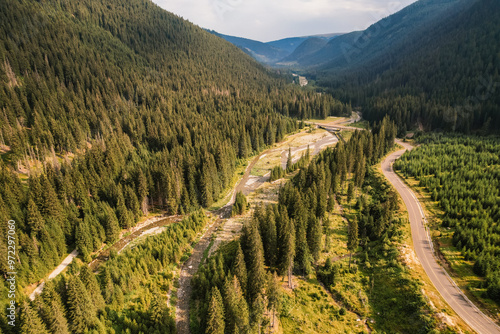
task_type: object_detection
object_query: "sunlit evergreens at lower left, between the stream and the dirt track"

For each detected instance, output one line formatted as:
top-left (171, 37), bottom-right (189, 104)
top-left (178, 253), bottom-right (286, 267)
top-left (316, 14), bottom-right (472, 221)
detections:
top-left (0, 210), bottom-right (207, 334)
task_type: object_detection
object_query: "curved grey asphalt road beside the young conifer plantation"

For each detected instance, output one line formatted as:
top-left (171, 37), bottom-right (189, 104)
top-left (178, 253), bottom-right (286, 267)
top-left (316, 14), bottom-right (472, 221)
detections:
top-left (382, 142), bottom-right (500, 334)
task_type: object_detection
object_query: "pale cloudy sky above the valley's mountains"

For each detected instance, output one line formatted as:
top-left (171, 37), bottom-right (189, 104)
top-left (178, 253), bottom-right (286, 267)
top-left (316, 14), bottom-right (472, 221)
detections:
top-left (153, 0), bottom-right (415, 42)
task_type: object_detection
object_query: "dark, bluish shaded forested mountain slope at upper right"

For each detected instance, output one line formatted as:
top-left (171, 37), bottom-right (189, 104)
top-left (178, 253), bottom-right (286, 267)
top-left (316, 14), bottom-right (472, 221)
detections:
top-left (312, 0), bottom-right (500, 132)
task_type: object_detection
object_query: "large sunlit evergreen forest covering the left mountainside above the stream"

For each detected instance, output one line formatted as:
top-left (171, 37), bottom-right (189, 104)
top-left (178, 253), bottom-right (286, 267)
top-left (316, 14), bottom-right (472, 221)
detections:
top-left (0, 0), bottom-right (346, 314)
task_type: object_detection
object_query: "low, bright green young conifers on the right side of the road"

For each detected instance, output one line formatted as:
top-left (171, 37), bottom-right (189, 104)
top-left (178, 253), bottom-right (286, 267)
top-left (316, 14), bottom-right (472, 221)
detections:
top-left (394, 135), bottom-right (500, 304)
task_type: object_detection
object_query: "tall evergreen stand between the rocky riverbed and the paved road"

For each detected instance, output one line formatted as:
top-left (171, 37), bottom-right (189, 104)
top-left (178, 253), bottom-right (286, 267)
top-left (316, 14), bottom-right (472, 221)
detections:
top-left (191, 119), bottom-right (442, 334)
